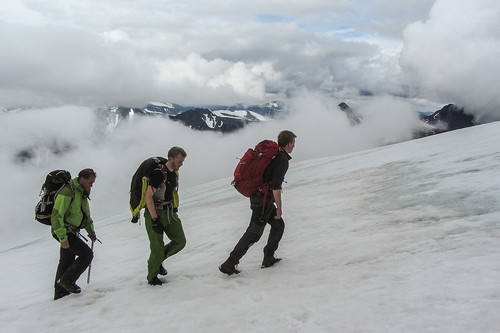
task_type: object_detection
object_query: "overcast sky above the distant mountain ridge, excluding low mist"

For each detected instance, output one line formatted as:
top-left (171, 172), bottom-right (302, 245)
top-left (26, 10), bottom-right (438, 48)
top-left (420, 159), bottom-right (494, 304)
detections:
top-left (0, 0), bottom-right (500, 116)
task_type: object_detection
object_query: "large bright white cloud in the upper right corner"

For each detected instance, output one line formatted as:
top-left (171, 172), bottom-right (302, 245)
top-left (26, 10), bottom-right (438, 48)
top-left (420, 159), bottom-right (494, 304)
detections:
top-left (401, 0), bottom-right (500, 120)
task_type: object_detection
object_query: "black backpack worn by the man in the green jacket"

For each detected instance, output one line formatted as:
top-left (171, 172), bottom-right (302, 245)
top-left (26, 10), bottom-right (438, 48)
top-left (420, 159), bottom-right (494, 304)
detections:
top-left (35, 170), bottom-right (75, 225)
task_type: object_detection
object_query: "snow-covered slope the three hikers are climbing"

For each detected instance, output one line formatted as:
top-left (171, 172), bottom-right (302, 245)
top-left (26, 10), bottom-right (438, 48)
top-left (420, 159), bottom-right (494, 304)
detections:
top-left (0, 123), bottom-right (500, 332)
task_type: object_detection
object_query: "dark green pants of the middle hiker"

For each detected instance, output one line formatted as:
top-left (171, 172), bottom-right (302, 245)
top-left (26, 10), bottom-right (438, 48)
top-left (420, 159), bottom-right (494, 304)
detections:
top-left (144, 208), bottom-right (186, 281)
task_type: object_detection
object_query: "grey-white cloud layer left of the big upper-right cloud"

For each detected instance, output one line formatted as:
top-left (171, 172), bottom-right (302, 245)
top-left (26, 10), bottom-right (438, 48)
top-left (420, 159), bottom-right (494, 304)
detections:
top-left (0, 0), bottom-right (438, 107)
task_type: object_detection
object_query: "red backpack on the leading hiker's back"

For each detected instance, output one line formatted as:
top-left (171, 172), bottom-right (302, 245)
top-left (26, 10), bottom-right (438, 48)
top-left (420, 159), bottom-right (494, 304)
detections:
top-left (231, 140), bottom-right (279, 197)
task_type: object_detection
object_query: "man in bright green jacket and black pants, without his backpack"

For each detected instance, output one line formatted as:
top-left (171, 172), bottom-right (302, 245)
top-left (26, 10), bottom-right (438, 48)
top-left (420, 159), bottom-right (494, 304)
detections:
top-left (50, 169), bottom-right (97, 300)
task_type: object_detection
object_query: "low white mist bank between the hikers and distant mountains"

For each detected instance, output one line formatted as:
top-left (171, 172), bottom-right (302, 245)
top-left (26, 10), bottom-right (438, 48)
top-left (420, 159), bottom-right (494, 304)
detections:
top-left (0, 90), bottom-right (430, 249)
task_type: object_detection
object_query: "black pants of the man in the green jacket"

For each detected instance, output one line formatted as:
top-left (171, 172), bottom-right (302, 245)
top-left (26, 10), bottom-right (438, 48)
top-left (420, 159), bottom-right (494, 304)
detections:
top-left (54, 233), bottom-right (94, 292)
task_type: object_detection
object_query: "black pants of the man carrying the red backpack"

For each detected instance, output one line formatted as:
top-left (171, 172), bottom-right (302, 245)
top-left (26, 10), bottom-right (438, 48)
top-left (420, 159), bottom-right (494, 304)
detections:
top-left (229, 195), bottom-right (285, 265)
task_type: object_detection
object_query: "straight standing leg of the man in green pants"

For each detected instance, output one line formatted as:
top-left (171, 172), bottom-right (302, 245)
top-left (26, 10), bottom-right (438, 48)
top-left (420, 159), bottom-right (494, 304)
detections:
top-left (144, 209), bottom-right (166, 281)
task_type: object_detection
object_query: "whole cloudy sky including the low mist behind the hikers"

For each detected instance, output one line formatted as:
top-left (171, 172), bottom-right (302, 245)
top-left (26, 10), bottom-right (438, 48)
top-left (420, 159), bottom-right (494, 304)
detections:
top-left (0, 0), bottom-right (500, 237)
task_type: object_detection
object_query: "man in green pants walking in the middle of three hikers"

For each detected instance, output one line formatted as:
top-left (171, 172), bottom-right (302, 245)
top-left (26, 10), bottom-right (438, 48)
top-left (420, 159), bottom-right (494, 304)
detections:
top-left (136, 147), bottom-right (187, 285)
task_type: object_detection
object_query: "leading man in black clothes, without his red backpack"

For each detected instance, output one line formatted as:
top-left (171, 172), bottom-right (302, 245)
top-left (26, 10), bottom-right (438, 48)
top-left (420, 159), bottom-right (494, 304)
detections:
top-left (219, 131), bottom-right (297, 275)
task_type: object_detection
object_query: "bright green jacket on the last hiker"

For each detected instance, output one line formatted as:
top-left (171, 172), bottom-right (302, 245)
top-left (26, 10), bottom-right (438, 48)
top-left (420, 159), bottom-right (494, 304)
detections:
top-left (50, 177), bottom-right (95, 243)
